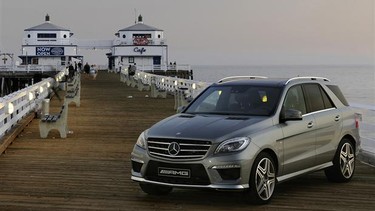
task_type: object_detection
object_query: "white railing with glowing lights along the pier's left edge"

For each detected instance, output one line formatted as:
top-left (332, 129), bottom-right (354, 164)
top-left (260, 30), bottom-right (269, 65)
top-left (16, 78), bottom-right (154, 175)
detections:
top-left (0, 68), bottom-right (67, 138)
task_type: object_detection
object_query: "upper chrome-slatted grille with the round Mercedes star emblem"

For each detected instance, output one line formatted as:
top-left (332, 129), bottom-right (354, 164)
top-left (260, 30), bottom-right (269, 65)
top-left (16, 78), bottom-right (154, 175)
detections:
top-left (147, 138), bottom-right (211, 159)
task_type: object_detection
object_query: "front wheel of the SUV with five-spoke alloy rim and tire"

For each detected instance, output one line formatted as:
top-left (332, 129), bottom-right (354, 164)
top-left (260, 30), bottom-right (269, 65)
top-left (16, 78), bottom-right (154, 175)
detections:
top-left (246, 152), bottom-right (276, 204)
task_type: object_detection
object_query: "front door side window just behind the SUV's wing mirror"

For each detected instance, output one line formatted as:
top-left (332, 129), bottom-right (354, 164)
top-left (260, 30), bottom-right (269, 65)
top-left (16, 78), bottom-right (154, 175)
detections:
top-left (283, 86), bottom-right (306, 114)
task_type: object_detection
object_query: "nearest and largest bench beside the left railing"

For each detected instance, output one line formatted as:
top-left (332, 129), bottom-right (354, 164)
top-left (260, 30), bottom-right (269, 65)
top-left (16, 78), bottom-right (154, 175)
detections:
top-left (39, 103), bottom-right (69, 138)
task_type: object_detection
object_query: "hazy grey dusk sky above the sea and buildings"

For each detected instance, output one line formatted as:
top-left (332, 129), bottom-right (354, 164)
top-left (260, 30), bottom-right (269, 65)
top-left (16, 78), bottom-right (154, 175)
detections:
top-left (0, 0), bottom-right (375, 65)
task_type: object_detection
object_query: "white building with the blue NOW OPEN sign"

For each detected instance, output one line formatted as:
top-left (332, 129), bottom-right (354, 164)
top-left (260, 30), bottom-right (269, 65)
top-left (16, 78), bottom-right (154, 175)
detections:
top-left (19, 14), bottom-right (82, 65)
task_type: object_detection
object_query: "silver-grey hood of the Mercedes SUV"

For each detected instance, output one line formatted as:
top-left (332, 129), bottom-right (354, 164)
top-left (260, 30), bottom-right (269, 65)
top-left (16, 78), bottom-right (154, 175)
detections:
top-left (147, 114), bottom-right (269, 140)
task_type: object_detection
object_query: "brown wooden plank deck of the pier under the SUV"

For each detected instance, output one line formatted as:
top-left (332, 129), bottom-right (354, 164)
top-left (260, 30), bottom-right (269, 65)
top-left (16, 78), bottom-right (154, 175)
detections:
top-left (0, 72), bottom-right (375, 211)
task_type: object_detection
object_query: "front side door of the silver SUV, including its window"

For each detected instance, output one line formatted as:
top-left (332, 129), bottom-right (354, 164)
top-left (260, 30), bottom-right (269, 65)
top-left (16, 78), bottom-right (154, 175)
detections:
top-left (280, 85), bottom-right (316, 175)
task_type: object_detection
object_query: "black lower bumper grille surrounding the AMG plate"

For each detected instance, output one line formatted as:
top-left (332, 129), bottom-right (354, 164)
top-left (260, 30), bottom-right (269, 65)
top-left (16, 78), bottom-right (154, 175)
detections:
top-left (145, 161), bottom-right (210, 185)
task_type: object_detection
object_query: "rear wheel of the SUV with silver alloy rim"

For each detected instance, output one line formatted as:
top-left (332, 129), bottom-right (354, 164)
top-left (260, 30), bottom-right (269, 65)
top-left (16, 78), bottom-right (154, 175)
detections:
top-left (324, 138), bottom-right (356, 182)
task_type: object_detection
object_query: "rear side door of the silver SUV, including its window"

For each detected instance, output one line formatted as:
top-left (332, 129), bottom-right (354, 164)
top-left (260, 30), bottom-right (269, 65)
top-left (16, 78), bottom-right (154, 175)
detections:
top-left (303, 84), bottom-right (342, 165)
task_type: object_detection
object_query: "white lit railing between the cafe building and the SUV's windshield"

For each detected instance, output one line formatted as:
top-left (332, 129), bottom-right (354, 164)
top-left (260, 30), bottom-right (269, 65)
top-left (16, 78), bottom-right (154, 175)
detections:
top-left (120, 68), bottom-right (210, 109)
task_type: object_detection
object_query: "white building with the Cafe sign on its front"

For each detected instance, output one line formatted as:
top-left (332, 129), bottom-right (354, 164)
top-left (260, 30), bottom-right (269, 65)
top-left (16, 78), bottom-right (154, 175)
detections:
top-left (107, 15), bottom-right (168, 70)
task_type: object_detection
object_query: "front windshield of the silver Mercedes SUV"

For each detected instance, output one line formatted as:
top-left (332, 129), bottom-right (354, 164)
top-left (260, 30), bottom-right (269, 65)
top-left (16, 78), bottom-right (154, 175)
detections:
top-left (184, 85), bottom-right (281, 116)
